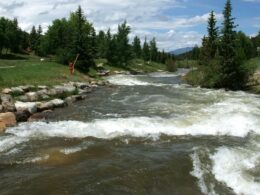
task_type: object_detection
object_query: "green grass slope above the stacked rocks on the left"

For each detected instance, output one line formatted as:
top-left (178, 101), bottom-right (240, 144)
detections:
top-left (0, 55), bottom-right (88, 88)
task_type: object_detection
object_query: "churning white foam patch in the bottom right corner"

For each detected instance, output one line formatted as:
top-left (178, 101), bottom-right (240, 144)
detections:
top-left (211, 144), bottom-right (260, 195)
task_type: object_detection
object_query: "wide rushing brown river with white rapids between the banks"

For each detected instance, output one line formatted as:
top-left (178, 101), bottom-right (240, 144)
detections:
top-left (0, 70), bottom-right (260, 195)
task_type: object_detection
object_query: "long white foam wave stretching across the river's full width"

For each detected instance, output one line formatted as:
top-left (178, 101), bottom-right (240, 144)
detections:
top-left (7, 107), bottom-right (260, 139)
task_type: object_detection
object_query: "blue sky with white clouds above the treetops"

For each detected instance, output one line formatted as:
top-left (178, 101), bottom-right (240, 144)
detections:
top-left (0, 0), bottom-right (260, 51)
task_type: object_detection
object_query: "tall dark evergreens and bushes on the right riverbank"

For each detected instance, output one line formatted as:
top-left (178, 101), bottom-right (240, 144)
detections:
top-left (189, 0), bottom-right (260, 90)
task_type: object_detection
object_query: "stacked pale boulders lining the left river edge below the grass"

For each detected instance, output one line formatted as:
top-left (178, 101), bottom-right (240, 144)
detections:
top-left (0, 81), bottom-right (110, 133)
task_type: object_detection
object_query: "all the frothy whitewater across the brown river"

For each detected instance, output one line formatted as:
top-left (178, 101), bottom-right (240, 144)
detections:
top-left (0, 73), bottom-right (260, 195)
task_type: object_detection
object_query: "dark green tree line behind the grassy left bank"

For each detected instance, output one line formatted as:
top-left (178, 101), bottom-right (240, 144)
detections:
top-left (0, 6), bottom-right (173, 71)
